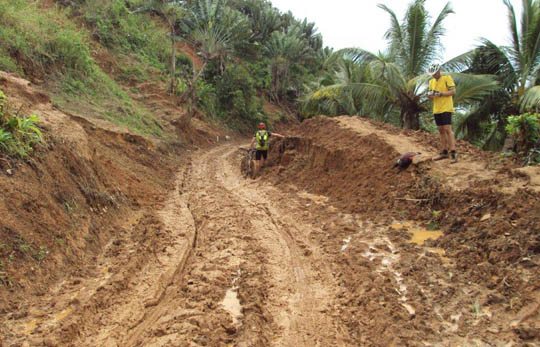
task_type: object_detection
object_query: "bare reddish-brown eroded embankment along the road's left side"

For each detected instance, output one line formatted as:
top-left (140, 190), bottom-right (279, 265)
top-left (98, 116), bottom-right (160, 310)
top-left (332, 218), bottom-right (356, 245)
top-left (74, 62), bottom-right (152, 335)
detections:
top-left (0, 73), bottom-right (188, 320)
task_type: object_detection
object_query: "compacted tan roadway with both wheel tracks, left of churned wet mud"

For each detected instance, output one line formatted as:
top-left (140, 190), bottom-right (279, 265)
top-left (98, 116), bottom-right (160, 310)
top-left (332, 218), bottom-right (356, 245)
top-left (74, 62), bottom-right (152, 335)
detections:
top-left (5, 145), bottom-right (351, 346)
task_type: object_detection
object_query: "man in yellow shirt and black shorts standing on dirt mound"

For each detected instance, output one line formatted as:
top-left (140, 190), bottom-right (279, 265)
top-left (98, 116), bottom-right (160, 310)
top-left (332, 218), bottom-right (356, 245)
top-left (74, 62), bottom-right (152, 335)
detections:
top-left (428, 64), bottom-right (457, 163)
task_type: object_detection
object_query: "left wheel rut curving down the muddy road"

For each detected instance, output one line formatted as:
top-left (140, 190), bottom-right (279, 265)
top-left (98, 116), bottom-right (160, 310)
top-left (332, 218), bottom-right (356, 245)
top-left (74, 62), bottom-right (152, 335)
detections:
top-left (81, 161), bottom-right (197, 346)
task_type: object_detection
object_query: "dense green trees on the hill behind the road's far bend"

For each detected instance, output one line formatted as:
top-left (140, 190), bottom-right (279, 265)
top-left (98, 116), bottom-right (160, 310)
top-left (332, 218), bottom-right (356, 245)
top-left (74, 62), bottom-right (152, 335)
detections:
top-left (167, 0), bottom-right (328, 127)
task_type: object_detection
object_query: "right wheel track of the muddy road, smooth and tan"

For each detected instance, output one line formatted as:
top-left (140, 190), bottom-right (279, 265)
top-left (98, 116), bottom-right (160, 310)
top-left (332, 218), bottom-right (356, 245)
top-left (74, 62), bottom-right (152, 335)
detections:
top-left (215, 145), bottom-right (349, 346)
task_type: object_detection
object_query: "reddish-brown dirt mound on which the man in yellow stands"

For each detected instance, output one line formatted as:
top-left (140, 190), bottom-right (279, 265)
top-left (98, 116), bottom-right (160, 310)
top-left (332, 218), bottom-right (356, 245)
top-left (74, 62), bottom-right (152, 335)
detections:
top-left (266, 117), bottom-right (540, 261)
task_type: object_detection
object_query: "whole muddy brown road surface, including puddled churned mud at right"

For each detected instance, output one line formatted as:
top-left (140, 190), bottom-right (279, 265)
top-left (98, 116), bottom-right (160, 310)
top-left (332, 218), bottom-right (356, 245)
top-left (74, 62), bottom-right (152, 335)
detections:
top-left (3, 135), bottom-right (538, 347)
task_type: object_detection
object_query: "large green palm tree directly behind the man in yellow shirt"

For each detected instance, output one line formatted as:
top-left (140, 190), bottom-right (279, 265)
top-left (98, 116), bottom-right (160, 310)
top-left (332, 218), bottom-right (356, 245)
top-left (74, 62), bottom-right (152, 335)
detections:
top-left (302, 0), bottom-right (495, 129)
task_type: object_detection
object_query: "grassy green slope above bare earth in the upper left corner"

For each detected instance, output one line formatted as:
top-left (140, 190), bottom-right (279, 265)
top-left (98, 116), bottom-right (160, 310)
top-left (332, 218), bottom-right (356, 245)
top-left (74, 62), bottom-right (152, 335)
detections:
top-left (0, 0), bottom-right (163, 138)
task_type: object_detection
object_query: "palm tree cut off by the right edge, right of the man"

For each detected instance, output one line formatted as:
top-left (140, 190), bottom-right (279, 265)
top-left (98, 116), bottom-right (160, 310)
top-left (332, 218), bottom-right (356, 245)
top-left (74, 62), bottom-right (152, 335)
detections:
top-left (458, 0), bottom-right (540, 149)
